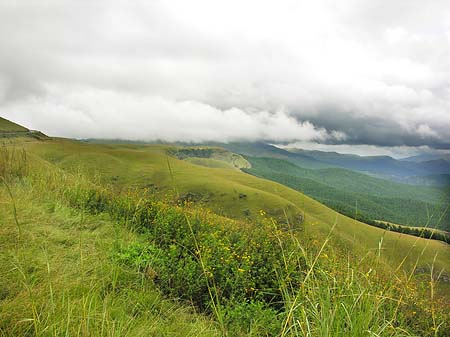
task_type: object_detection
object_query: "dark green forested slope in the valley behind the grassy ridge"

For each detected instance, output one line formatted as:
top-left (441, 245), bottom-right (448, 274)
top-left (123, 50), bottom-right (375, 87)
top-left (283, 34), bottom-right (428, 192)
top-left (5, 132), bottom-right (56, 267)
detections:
top-left (246, 157), bottom-right (450, 229)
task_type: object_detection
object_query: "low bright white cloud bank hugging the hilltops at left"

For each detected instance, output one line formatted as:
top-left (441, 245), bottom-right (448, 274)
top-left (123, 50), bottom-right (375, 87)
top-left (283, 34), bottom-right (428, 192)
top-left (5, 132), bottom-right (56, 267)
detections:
top-left (0, 87), bottom-right (343, 142)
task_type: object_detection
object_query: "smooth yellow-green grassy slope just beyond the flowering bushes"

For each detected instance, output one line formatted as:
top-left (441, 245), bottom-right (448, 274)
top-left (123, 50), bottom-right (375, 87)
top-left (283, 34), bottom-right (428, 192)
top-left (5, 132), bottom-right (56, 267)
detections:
top-left (7, 140), bottom-right (450, 269)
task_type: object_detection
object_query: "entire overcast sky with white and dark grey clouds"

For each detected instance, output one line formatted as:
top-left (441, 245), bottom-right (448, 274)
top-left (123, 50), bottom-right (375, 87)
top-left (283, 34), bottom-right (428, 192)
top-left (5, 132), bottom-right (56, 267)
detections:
top-left (0, 0), bottom-right (450, 157)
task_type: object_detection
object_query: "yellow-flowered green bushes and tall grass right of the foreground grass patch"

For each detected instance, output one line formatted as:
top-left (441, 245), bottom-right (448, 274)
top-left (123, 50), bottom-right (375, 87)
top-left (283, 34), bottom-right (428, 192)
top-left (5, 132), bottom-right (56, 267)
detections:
top-left (50, 180), bottom-right (448, 336)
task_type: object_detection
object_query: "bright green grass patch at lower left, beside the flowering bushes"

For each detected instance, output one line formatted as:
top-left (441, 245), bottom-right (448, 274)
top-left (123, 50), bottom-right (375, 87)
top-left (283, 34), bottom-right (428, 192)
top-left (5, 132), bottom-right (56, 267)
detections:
top-left (0, 175), bottom-right (221, 337)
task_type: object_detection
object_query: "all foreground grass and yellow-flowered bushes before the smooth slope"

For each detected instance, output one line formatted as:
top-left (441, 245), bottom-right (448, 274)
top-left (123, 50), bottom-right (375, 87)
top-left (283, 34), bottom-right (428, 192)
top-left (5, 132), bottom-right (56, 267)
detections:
top-left (0, 138), bottom-right (450, 336)
